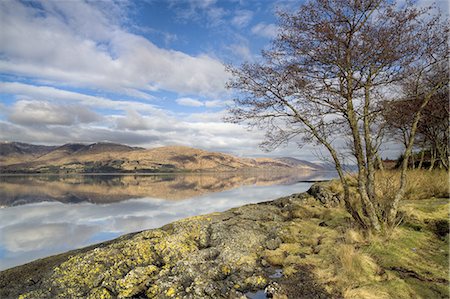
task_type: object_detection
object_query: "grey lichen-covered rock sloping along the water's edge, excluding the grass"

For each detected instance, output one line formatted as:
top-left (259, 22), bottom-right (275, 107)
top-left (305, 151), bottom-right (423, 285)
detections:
top-left (0, 184), bottom-right (333, 298)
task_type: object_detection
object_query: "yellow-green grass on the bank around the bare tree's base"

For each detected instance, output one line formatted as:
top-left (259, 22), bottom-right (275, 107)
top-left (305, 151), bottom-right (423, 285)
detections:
top-left (265, 170), bottom-right (450, 299)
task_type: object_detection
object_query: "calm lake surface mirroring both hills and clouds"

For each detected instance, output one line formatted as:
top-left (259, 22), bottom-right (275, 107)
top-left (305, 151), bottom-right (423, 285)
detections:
top-left (0, 172), bottom-right (334, 270)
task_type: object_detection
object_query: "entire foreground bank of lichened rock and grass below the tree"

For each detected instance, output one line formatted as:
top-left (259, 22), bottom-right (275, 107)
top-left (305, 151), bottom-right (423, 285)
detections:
top-left (0, 183), bottom-right (449, 299)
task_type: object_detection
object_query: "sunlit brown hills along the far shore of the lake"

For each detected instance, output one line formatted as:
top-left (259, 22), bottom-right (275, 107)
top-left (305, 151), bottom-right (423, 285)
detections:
top-left (0, 143), bottom-right (323, 173)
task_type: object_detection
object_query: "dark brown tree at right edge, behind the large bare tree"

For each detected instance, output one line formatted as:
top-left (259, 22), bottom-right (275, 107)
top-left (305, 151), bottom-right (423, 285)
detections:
top-left (383, 61), bottom-right (449, 170)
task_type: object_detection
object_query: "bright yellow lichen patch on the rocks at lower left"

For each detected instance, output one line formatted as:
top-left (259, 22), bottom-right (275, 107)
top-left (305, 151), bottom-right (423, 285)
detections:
top-left (42, 219), bottom-right (206, 298)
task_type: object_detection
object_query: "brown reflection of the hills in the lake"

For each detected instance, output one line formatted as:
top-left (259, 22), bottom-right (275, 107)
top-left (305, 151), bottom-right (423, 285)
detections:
top-left (0, 172), bottom-right (330, 207)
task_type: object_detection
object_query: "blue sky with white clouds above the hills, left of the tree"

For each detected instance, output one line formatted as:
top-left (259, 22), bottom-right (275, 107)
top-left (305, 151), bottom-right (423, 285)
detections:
top-left (0, 0), bottom-right (446, 161)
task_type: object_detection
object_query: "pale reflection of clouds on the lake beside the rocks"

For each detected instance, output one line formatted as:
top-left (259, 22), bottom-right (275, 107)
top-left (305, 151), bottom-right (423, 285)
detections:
top-left (0, 172), bottom-right (338, 270)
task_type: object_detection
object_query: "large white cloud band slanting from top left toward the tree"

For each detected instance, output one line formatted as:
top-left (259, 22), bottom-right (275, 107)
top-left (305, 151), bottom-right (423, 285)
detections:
top-left (0, 1), bottom-right (228, 97)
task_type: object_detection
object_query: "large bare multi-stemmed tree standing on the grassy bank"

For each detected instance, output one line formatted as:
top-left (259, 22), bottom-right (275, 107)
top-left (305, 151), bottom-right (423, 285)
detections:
top-left (228, 0), bottom-right (448, 231)
